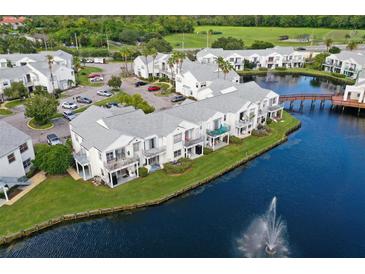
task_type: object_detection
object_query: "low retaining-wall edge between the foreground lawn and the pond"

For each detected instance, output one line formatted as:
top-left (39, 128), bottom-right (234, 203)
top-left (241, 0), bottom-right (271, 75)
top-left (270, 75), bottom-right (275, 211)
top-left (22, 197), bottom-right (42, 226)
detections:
top-left (0, 117), bottom-right (301, 246)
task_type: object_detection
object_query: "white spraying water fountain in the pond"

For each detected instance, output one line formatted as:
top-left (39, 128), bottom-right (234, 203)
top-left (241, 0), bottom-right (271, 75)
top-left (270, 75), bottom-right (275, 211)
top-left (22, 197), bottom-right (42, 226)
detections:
top-left (238, 197), bottom-right (289, 258)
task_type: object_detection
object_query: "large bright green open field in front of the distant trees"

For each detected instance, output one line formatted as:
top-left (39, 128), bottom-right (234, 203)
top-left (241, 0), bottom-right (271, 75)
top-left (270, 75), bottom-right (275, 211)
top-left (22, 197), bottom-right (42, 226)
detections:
top-left (165, 26), bottom-right (365, 48)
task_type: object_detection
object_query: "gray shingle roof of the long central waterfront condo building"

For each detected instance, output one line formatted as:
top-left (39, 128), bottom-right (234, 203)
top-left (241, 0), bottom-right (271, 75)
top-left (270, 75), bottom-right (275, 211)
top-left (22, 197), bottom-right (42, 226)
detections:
top-left (70, 81), bottom-right (271, 151)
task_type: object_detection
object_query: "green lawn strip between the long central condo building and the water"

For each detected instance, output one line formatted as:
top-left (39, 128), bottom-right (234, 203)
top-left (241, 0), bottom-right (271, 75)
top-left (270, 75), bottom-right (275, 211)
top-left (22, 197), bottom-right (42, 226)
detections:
top-left (0, 113), bottom-right (299, 236)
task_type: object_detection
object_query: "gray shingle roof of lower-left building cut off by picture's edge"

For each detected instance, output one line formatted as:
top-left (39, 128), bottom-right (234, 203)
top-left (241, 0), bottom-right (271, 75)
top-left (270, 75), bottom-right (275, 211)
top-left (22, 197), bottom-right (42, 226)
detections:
top-left (0, 121), bottom-right (30, 157)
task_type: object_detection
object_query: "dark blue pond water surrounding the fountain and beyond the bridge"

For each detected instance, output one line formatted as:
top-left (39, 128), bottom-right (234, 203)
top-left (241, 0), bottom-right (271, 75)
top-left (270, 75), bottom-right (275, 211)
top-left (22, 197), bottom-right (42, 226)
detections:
top-left (0, 74), bottom-right (365, 257)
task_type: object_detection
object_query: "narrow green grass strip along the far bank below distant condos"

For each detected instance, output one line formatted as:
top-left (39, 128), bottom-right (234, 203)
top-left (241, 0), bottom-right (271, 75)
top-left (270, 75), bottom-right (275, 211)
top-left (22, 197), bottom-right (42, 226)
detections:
top-left (238, 68), bottom-right (355, 85)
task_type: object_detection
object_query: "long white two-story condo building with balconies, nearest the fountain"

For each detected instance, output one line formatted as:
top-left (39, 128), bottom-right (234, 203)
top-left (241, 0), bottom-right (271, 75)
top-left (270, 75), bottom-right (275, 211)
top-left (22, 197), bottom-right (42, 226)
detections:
top-left (70, 82), bottom-right (283, 187)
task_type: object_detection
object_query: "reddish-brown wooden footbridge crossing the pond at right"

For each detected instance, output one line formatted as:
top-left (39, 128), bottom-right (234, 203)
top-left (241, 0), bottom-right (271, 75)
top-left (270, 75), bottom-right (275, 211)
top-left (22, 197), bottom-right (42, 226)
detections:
top-left (279, 93), bottom-right (365, 113)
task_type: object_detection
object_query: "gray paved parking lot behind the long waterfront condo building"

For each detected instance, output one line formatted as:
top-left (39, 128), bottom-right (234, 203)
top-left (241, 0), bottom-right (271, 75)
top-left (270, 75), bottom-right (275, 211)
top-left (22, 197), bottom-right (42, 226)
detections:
top-left (0, 63), bottom-right (173, 143)
